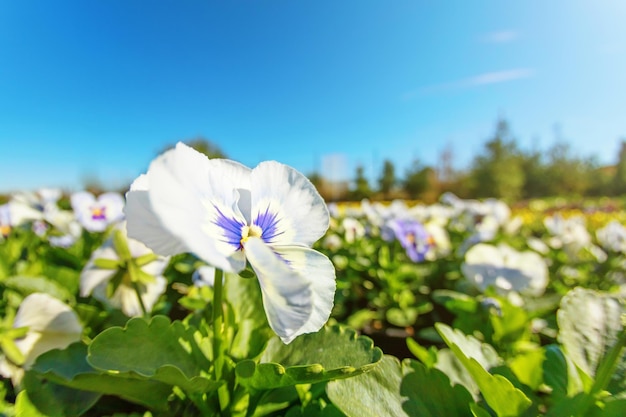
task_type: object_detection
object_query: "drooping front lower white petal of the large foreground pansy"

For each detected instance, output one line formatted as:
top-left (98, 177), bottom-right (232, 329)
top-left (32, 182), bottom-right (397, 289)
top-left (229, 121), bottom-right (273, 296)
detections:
top-left (245, 238), bottom-right (313, 343)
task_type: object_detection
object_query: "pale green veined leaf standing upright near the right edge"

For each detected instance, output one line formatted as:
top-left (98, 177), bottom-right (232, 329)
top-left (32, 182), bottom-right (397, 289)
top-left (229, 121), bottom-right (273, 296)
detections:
top-left (557, 287), bottom-right (625, 379)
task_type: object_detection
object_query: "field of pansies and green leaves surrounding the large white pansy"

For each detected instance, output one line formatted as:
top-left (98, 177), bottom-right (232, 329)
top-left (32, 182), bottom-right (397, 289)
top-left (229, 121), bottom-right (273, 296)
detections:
top-left (0, 176), bottom-right (626, 416)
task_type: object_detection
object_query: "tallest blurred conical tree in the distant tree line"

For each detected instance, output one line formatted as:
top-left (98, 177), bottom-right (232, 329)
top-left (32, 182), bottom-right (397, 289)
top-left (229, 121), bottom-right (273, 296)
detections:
top-left (470, 119), bottom-right (525, 201)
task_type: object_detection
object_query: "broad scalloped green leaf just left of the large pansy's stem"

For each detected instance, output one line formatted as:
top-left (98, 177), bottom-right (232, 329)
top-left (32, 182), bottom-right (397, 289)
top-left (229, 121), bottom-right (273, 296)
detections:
top-left (87, 316), bottom-right (220, 392)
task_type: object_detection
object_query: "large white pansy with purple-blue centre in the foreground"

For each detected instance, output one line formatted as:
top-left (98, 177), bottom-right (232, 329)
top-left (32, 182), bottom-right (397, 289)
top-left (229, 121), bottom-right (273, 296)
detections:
top-left (126, 143), bottom-right (335, 343)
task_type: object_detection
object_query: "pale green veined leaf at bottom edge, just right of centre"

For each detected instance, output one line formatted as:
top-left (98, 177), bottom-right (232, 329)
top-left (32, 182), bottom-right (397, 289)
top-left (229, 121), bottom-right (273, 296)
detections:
top-left (326, 355), bottom-right (409, 417)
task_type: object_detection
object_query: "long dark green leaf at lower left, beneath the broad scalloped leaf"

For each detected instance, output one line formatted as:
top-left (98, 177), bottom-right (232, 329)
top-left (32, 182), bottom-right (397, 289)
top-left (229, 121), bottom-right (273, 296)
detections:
top-left (29, 343), bottom-right (172, 410)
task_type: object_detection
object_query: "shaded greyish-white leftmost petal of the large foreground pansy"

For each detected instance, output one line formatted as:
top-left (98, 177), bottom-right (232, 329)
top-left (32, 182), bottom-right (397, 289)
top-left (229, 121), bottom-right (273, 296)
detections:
top-left (124, 175), bottom-right (188, 256)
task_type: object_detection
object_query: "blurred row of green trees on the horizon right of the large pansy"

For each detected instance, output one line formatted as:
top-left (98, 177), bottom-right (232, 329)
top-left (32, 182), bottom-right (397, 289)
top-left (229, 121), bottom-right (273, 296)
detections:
top-left (309, 119), bottom-right (626, 202)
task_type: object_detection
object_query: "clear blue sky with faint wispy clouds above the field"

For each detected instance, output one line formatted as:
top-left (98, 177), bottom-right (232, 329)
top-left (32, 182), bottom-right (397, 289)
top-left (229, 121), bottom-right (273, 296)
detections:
top-left (0, 0), bottom-right (626, 192)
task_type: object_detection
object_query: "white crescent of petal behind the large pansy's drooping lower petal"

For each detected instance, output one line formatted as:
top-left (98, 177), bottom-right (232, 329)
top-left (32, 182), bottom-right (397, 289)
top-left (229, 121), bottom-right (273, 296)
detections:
top-left (272, 246), bottom-right (337, 334)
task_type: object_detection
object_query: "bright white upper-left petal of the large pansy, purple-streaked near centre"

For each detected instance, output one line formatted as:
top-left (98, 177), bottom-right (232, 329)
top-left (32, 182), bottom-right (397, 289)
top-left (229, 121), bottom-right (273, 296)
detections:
top-left (144, 143), bottom-right (245, 272)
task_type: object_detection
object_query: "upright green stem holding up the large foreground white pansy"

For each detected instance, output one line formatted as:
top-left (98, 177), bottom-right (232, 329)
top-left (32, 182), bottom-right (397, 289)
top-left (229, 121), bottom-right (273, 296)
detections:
top-left (213, 268), bottom-right (229, 411)
